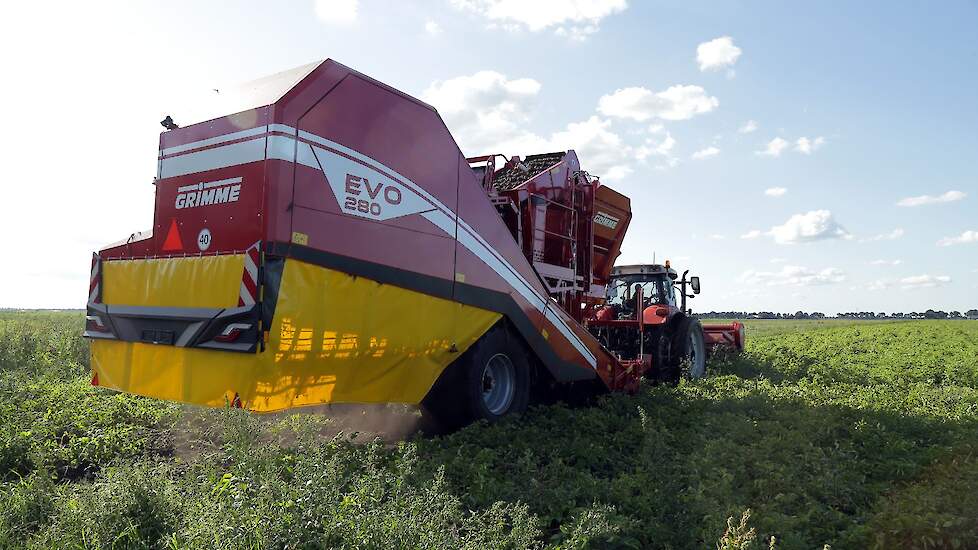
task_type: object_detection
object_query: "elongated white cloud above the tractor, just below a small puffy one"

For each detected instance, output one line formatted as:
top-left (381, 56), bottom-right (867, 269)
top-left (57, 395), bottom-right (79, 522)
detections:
top-left (598, 85), bottom-right (720, 122)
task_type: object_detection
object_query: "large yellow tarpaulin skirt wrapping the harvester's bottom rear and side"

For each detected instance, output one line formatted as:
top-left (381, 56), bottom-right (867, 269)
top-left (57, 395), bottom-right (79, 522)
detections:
top-left (92, 260), bottom-right (500, 412)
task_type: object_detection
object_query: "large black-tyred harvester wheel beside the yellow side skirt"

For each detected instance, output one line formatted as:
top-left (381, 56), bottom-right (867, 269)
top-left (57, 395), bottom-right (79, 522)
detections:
top-left (422, 326), bottom-right (530, 430)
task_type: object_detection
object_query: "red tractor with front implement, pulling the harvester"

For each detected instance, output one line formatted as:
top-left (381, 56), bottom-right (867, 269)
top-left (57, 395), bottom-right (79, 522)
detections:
top-left (585, 266), bottom-right (744, 382)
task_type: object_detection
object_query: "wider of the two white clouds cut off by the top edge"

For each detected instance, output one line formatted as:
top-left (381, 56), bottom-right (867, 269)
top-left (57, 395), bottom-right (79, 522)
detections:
top-left (451, 0), bottom-right (628, 39)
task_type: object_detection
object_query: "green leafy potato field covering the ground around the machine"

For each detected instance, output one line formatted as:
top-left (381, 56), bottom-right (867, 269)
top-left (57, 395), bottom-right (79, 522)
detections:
top-left (0, 312), bottom-right (978, 549)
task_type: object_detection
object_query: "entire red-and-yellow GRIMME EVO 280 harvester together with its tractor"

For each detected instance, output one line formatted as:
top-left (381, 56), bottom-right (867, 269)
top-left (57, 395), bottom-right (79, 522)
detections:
top-left (85, 60), bottom-right (743, 424)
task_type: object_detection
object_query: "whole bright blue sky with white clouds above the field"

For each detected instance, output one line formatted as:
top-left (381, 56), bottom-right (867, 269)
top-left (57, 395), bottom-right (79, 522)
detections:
top-left (0, 0), bottom-right (978, 313)
